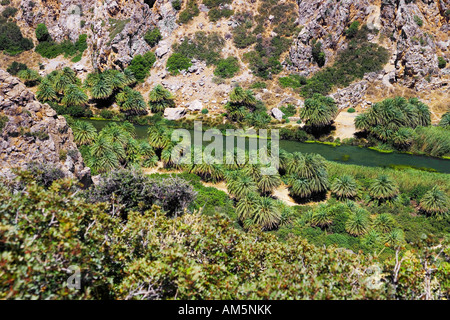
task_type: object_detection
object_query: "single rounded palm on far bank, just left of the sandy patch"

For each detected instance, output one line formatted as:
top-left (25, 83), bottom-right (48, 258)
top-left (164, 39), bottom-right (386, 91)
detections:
top-left (300, 93), bottom-right (338, 128)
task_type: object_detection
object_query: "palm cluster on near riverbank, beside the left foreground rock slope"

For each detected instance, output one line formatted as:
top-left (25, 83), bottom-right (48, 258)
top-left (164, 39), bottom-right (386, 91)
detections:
top-left (72, 121), bottom-right (158, 173)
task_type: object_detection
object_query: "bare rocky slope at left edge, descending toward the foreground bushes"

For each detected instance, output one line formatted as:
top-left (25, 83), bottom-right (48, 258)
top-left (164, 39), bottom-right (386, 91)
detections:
top-left (0, 69), bottom-right (91, 186)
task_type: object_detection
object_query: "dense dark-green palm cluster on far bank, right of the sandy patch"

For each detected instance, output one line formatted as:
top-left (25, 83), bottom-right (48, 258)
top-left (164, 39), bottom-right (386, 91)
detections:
top-left (355, 97), bottom-right (431, 149)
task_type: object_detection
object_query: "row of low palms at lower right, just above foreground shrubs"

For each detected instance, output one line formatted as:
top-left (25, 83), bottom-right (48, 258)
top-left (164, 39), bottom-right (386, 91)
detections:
top-left (300, 201), bottom-right (404, 246)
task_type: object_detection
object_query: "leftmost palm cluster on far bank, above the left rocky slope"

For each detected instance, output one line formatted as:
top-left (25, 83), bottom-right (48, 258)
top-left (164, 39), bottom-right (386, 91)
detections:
top-left (36, 67), bottom-right (89, 107)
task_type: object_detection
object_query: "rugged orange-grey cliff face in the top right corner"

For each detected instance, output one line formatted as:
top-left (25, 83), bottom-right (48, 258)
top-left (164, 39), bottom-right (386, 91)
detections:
top-left (290, 0), bottom-right (450, 90)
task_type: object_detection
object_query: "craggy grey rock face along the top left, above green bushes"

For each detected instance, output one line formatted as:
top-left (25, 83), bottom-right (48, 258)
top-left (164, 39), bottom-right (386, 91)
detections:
top-left (17, 0), bottom-right (177, 70)
